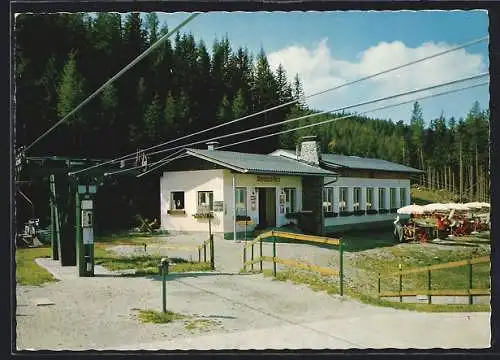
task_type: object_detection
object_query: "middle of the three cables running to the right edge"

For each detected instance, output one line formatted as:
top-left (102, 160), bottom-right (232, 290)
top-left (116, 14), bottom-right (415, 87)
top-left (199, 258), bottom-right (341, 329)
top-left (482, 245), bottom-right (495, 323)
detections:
top-left (123, 72), bottom-right (488, 156)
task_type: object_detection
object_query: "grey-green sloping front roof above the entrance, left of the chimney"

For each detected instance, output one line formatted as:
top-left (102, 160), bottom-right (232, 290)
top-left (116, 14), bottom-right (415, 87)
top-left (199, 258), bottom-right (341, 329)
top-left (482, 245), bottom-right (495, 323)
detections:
top-left (186, 149), bottom-right (336, 176)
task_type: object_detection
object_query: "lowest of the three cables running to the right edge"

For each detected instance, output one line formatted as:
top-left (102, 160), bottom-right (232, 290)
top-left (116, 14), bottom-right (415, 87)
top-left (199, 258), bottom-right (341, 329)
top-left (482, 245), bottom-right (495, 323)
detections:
top-left (133, 81), bottom-right (489, 177)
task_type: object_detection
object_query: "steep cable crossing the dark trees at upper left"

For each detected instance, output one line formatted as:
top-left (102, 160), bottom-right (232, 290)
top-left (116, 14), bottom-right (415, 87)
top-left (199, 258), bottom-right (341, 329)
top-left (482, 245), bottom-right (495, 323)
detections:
top-left (19, 13), bottom-right (199, 154)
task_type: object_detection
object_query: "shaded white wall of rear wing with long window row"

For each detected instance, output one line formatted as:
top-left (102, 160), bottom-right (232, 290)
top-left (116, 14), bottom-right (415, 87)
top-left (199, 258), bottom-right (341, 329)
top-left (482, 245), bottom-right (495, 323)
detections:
top-left (325, 177), bottom-right (410, 227)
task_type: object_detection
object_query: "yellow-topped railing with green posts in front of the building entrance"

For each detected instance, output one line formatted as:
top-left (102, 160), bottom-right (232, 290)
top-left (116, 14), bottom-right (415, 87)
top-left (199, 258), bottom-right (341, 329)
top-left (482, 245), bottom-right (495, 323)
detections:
top-left (243, 231), bottom-right (344, 296)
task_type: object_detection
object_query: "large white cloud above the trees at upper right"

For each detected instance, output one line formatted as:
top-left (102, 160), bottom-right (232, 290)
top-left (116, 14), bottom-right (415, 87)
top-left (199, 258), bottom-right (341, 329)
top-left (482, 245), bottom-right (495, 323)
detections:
top-left (268, 38), bottom-right (488, 120)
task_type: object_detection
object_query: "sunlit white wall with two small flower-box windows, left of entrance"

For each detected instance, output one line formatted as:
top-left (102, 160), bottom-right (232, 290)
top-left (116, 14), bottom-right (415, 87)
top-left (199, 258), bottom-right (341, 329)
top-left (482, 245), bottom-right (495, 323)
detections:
top-left (160, 170), bottom-right (224, 233)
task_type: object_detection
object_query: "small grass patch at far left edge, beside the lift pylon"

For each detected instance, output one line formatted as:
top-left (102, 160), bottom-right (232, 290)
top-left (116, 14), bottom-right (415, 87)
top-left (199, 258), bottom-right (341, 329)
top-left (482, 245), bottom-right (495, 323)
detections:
top-left (16, 246), bottom-right (57, 285)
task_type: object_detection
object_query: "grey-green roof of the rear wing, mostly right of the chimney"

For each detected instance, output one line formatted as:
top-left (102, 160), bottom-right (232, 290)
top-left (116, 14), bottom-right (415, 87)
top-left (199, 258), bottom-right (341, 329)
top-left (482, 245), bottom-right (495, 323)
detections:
top-left (274, 149), bottom-right (423, 173)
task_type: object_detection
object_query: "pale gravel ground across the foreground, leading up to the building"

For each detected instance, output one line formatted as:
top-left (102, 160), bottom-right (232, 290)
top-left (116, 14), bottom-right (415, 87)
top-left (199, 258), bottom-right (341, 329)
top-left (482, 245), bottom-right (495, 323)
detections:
top-left (16, 235), bottom-right (490, 350)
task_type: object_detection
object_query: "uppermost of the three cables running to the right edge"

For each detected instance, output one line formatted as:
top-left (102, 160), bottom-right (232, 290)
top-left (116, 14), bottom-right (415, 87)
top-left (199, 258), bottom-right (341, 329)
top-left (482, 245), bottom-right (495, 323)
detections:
top-left (71, 36), bottom-right (489, 174)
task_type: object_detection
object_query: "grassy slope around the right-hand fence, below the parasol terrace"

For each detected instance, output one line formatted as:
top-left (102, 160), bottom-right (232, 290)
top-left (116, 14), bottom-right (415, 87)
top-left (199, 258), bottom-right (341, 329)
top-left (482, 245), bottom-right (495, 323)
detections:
top-left (264, 228), bottom-right (491, 312)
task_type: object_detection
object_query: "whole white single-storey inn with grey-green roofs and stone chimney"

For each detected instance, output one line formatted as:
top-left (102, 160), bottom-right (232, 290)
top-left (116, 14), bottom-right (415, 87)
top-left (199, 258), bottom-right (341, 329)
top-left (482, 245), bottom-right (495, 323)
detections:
top-left (160, 138), bottom-right (420, 239)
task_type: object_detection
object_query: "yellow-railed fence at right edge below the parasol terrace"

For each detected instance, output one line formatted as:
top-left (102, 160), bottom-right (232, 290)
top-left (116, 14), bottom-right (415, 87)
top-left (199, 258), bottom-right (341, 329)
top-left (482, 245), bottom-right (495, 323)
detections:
top-left (378, 256), bottom-right (491, 304)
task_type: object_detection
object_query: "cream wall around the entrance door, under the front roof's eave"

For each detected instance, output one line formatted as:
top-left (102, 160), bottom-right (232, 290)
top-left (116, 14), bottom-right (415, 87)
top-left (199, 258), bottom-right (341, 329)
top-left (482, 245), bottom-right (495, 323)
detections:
top-left (224, 170), bottom-right (302, 232)
